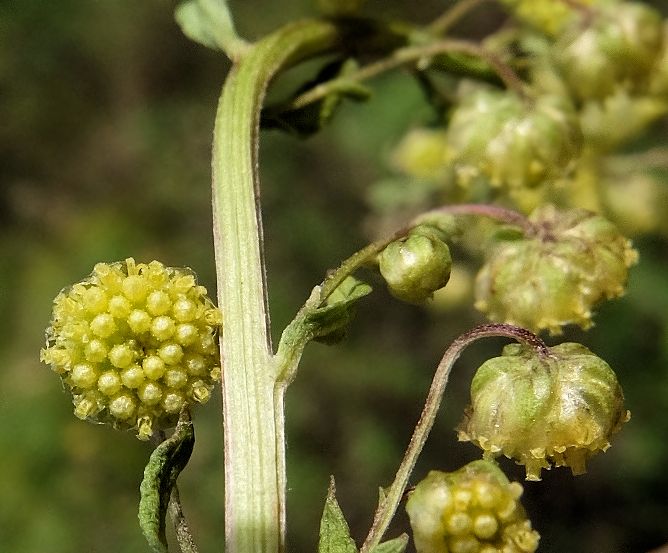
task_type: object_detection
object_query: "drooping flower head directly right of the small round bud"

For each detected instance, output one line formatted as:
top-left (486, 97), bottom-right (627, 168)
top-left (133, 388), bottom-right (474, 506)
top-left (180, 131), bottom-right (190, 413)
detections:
top-left (475, 205), bottom-right (637, 334)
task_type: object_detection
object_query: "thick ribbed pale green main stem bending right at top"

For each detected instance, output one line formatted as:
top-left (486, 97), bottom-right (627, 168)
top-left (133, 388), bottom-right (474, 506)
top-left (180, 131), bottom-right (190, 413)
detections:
top-left (212, 17), bottom-right (337, 553)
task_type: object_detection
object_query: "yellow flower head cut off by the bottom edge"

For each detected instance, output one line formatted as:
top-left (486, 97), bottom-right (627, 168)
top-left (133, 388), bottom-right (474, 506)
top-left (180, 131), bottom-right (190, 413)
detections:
top-left (406, 460), bottom-right (540, 553)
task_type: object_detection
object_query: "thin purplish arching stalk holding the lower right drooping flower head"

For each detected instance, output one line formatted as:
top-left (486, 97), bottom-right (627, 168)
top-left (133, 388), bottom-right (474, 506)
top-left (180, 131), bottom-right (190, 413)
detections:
top-left (360, 324), bottom-right (549, 553)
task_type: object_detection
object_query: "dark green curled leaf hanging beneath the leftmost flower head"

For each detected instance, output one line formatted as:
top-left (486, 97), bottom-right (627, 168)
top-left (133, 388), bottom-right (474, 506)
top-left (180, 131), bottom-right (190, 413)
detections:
top-left (139, 409), bottom-right (195, 553)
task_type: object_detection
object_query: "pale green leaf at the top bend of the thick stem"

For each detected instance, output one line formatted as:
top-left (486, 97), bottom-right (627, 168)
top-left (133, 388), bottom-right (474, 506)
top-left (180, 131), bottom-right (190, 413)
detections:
top-left (174, 0), bottom-right (247, 59)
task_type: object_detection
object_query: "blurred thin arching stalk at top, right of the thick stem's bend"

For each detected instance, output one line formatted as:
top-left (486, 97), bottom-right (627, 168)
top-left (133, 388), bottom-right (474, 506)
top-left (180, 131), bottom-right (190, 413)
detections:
top-left (282, 40), bottom-right (526, 111)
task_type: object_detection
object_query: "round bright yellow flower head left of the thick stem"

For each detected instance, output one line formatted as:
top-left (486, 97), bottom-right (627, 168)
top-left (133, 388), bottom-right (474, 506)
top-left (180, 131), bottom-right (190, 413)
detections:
top-left (40, 258), bottom-right (222, 440)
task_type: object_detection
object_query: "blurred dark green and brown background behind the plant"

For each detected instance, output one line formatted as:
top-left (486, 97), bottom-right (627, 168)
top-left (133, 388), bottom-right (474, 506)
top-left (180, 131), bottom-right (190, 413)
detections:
top-left (0, 0), bottom-right (668, 553)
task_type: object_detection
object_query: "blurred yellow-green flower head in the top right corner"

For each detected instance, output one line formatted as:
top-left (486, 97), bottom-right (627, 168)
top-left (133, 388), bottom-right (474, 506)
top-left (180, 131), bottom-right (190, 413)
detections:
top-left (555, 2), bottom-right (663, 101)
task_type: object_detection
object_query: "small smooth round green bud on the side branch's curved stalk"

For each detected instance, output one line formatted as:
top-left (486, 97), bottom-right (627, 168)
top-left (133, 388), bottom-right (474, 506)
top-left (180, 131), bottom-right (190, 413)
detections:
top-left (378, 226), bottom-right (452, 303)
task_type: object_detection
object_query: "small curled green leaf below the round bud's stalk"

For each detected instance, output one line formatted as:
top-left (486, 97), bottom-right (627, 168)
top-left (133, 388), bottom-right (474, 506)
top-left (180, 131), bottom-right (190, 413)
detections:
top-left (307, 276), bottom-right (372, 344)
